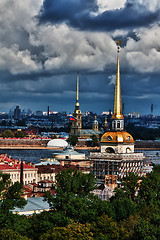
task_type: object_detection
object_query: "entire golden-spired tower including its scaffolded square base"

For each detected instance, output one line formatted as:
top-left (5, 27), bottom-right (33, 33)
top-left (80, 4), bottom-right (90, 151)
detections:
top-left (90, 41), bottom-right (148, 188)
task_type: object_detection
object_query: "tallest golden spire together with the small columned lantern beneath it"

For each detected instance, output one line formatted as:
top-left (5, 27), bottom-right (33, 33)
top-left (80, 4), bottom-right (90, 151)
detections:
top-left (111, 41), bottom-right (124, 131)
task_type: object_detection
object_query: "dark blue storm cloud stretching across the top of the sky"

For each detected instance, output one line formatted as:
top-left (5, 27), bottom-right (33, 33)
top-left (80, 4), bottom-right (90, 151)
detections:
top-left (39, 0), bottom-right (159, 31)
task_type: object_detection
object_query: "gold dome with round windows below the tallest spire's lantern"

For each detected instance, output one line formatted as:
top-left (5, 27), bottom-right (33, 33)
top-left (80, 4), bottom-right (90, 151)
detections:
top-left (101, 131), bottom-right (134, 143)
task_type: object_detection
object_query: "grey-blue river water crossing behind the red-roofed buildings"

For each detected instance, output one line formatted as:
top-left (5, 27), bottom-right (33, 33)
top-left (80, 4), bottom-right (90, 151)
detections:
top-left (0, 149), bottom-right (160, 164)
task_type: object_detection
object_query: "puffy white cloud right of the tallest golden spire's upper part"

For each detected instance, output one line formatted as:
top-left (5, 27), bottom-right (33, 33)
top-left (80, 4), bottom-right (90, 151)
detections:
top-left (124, 26), bottom-right (160, 73)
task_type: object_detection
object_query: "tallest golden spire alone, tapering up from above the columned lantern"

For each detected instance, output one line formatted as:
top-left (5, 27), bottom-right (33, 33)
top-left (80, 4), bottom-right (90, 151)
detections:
top-left (112, 40), bottom-right (124, 119)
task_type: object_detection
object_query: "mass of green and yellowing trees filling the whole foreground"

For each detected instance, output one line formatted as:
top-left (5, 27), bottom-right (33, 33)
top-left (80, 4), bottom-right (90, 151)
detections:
top-left (0, 166), bottom-right (160, 240)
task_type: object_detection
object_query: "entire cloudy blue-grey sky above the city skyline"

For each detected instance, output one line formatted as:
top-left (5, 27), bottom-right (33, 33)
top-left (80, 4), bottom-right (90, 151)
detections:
top-left (0, 0), bottom-right (160, 115)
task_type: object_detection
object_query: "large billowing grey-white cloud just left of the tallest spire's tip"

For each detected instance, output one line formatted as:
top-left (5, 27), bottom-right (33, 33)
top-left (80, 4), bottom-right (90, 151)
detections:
top-left (30, 24), bottom-right (116, 72)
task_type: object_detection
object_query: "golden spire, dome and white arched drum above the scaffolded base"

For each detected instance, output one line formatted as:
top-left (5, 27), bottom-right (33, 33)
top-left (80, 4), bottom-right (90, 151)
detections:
top-left (101, 41), bottom-right (134, 153)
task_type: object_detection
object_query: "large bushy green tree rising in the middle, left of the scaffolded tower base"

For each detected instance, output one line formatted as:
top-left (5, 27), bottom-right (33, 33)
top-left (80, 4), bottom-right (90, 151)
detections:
top-left (46, 169), bottom-right (95, 209)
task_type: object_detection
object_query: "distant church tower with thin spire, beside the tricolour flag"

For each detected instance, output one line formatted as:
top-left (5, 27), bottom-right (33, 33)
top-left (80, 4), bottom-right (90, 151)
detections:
top-left (70, 73), bottom-right (82, 135)
